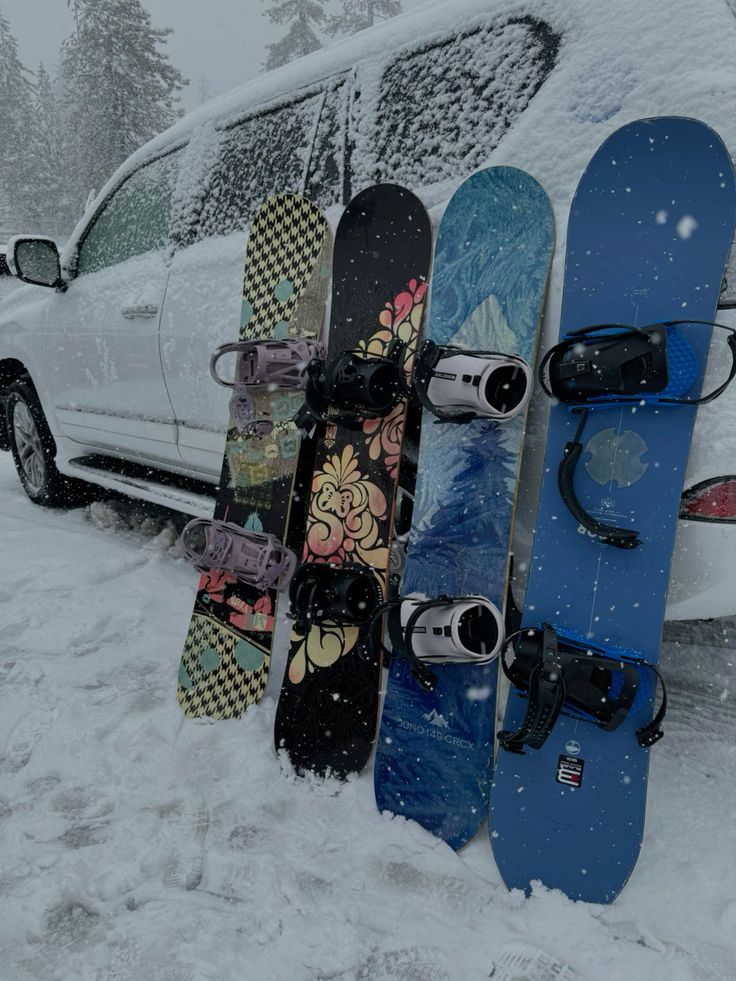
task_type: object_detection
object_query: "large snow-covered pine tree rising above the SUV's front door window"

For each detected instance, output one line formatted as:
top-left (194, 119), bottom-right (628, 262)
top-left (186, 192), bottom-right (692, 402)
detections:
top-left (61, 0), bottom-right (188, 213)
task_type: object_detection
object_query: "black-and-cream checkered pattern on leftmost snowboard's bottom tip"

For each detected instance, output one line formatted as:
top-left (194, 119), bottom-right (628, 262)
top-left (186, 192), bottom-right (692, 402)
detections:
top-left (177, 613), bottom-right (271, 719)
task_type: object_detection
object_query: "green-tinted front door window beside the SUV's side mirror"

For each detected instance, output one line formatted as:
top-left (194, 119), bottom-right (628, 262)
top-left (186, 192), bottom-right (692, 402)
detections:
top-left (77, 151), bottom-right (180, 275)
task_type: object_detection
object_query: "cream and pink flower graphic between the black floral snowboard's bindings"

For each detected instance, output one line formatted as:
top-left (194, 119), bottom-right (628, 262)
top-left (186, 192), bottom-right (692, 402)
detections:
top-left (304, 446), bottom-right (388, 569)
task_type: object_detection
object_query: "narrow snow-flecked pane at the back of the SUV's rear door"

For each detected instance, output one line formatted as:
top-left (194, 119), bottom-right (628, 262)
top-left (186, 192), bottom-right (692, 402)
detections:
top-left (304, 77), bottom-right (350, 208)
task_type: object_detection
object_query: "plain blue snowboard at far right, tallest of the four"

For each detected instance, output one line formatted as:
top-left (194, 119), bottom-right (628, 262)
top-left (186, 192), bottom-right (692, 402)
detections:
top-left (490, 117), bottom-right (736, 903)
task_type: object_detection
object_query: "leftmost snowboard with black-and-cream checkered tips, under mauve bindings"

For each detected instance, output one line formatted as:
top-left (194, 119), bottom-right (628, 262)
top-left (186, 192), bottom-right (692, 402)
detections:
top-left (177, 194), bottom-right (332, 719)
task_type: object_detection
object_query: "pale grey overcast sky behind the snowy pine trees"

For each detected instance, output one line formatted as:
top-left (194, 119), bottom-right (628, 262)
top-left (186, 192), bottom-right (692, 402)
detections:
top-left (0, 0), bottom-right (422, 109)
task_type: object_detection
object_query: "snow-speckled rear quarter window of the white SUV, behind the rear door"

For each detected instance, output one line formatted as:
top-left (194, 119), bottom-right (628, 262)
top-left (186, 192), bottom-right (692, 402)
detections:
top-left (366, 17), bottom-right (560, 187)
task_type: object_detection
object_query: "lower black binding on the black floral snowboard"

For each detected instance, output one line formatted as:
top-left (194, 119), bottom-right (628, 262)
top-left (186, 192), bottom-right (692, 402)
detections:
top-left (287, 562), bottom-right (383, 635)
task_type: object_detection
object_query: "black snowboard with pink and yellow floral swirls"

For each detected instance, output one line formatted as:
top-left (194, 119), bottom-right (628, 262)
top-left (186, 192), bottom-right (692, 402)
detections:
top-left (275, 184), bottom-right (431, 777)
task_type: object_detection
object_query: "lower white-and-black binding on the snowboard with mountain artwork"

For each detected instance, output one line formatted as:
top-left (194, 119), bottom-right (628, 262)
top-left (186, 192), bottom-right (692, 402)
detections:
top-left (374, 596), bottom-right (504, 691)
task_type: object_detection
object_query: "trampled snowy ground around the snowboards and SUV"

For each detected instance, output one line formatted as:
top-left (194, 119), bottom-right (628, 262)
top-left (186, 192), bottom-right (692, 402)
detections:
top-left (0, 454), bottom-right (736, 981)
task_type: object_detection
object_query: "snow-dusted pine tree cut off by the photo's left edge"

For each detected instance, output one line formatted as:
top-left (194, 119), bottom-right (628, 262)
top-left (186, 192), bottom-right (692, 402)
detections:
top-left (0, 14), bottom-right (34, 232)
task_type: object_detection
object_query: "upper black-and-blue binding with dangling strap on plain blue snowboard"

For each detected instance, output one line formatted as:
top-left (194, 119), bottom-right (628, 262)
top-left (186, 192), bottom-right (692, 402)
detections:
top-left (539, 320), bottom-right (736, 549)
